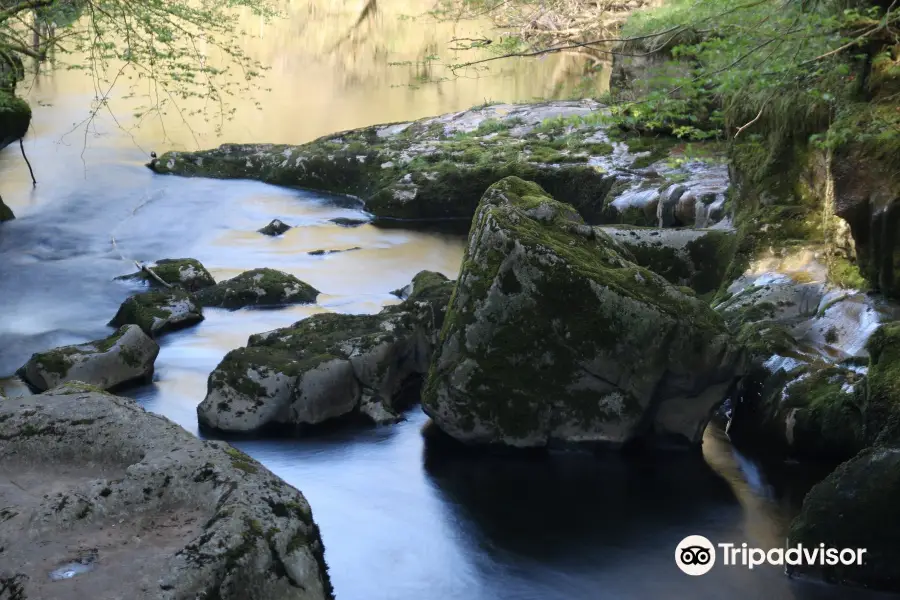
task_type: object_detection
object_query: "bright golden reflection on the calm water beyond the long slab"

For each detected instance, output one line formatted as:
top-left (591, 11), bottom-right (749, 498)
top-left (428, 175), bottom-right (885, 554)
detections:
top-left (23, 0), bottom-right (600, 149)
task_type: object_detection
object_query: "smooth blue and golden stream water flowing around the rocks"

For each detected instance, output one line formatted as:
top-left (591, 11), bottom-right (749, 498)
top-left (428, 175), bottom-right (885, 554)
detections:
top-left (0, 0), bottom-right (896, 600)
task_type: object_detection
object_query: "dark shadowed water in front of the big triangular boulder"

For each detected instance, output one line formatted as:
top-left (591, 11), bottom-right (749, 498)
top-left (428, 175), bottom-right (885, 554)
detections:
top-left (424, 428), bottom-right (895, 600)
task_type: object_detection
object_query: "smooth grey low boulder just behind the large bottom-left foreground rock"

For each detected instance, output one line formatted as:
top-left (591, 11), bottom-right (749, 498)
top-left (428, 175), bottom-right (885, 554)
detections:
top-left (19, 325), bottom-right (159, 391)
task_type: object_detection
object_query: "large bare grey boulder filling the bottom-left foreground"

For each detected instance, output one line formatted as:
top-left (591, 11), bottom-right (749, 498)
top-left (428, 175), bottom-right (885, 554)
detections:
top-left (0, 383), bottom-right (333, 600)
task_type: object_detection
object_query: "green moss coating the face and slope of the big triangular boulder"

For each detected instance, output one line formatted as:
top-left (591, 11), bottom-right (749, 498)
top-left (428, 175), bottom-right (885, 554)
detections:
top-left (423, 177), bottom-right (726, 438)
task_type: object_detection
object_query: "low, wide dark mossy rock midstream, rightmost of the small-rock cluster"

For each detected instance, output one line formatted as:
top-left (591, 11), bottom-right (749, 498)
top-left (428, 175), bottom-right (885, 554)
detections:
top-left (194, 269), bottom-right (319, 309)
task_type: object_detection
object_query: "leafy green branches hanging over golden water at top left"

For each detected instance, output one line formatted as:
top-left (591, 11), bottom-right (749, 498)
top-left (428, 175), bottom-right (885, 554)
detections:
top-left (0, 0), bottom-right (276, 132)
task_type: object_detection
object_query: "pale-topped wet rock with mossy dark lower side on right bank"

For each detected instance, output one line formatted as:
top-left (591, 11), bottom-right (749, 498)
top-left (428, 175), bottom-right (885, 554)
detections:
top-left (716, 250), bottom-right (898, 460)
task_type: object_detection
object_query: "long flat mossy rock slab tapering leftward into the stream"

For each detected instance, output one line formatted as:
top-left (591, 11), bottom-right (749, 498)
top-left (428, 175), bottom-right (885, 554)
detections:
top-left (151, 101), bottom-right (728, 225)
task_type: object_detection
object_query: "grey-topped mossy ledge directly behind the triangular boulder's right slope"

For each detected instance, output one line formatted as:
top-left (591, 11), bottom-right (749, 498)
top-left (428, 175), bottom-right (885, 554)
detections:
top-left (603, 227), bottom-right (734, 295)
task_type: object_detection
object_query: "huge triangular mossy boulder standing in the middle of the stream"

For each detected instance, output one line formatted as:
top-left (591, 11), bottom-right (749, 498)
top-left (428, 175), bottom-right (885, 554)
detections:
top-left (422, 178), bottom-right (742, 447)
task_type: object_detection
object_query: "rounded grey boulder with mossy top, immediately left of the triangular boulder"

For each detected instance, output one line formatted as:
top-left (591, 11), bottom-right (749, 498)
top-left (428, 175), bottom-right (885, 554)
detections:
top-left (197, 272), bottom-right (453, 432)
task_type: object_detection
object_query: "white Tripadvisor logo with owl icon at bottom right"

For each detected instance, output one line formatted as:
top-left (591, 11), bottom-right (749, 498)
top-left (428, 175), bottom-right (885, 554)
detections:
top-left (675, 535), bottom-right (866, 576)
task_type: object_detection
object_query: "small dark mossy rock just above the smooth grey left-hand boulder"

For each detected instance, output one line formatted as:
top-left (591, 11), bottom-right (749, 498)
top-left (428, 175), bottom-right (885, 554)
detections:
top-left (109, 290), bottom-right (204, 337)
